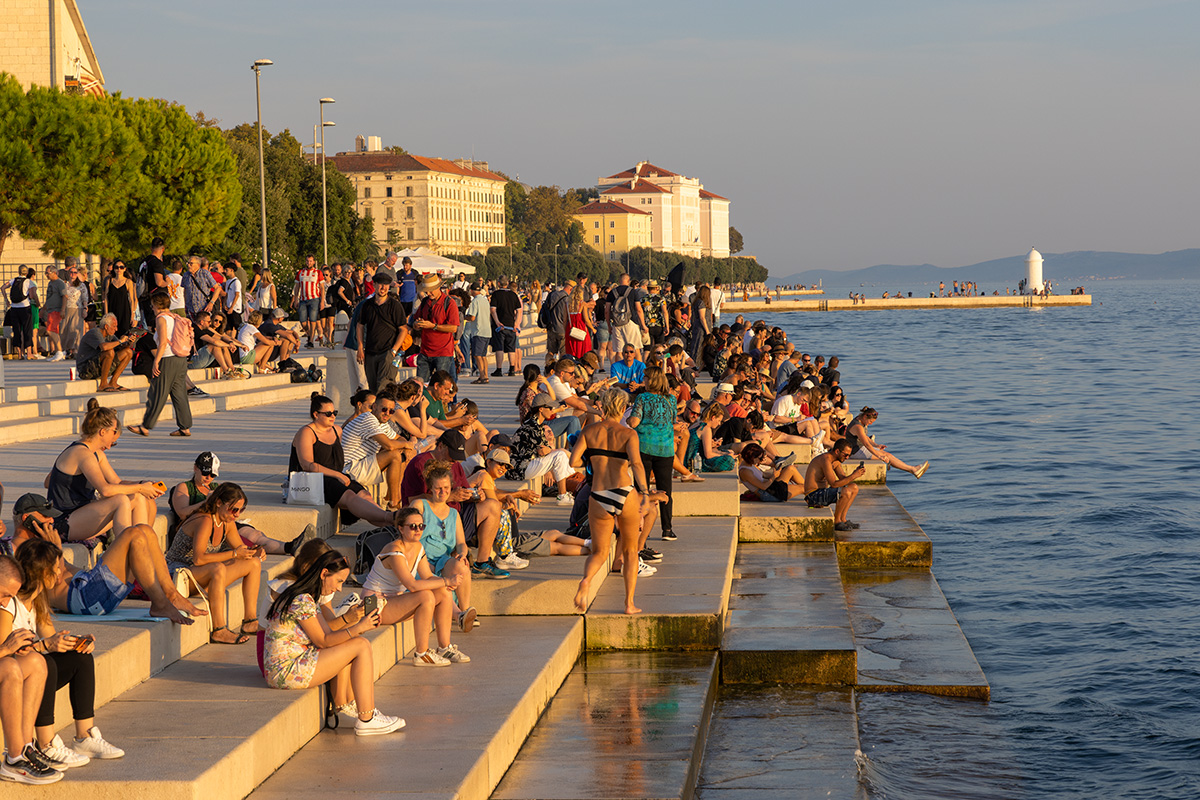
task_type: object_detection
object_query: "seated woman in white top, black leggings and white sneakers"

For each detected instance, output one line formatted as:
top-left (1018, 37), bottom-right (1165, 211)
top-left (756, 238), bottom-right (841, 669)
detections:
top-left (0, 539), bottom-right (125, 770)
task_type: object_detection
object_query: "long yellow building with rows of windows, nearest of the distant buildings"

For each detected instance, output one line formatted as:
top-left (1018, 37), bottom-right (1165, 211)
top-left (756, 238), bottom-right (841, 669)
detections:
top-left (328, 145), bottom-right (508, 254)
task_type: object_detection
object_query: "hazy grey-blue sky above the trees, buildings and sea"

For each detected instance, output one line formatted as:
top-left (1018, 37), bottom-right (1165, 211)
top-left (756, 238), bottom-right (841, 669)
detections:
top-left (79, 0), bottom-right (1200, 276)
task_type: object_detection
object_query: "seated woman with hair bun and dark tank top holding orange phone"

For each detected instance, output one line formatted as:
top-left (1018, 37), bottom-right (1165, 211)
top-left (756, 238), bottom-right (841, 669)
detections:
top-left (44, 397), bottom-right (164, 547)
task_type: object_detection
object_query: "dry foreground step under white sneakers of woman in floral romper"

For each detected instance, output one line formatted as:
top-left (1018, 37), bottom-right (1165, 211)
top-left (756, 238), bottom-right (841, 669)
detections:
top-left (252, 616), bottom-right (583, 800)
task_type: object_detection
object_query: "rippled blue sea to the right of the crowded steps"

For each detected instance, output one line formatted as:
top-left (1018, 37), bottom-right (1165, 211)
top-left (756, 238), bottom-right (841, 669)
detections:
top-left (762, 281), bottom-right (1200, 799)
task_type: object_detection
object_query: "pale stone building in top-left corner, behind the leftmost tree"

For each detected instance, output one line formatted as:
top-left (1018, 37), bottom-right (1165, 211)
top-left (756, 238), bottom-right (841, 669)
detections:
top-left (0, 0), bottom-right (104, 267)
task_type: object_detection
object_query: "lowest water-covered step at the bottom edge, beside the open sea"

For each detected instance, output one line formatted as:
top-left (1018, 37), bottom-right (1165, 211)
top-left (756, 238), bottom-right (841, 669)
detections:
top-left (696, 686), bottom-right (868, 800)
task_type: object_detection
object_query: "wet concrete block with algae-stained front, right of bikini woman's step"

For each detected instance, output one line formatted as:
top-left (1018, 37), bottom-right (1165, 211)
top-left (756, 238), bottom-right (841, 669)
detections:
top-left (721, 543), bottom-right (857, 686)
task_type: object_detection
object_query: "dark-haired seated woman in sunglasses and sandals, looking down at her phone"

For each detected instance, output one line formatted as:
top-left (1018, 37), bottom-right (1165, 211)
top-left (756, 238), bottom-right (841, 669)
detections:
top-left (167, 483), bottom-right (266, 644)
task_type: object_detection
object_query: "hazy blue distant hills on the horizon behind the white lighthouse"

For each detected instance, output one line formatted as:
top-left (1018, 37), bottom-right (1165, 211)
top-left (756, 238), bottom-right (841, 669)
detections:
top-left (768, 248), bottom-right (1200, 291)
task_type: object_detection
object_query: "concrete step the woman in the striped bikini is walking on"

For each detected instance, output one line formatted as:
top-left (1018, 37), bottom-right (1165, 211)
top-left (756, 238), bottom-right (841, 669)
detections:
top-left (586, 517), bottom-right (737, 650)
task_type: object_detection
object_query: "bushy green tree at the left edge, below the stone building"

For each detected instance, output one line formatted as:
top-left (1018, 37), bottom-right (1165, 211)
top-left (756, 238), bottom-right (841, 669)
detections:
top-left (0, 73), bottom-right (145, 255)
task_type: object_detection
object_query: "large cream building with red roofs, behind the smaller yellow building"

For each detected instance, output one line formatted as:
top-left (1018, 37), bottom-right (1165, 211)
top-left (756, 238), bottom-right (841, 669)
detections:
top-left (596, 161), bottom-right (730, 258)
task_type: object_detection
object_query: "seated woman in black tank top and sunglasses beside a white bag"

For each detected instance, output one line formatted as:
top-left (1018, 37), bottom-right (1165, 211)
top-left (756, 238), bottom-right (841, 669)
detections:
top-left (288, 392), bottom-right (403, 527)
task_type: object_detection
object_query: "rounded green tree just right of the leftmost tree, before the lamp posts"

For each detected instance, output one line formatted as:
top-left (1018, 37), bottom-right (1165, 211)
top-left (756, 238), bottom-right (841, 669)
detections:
top-left (110, 96), bottom-right (242, 253)
